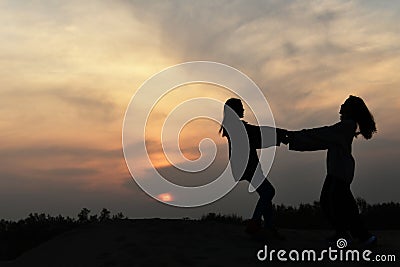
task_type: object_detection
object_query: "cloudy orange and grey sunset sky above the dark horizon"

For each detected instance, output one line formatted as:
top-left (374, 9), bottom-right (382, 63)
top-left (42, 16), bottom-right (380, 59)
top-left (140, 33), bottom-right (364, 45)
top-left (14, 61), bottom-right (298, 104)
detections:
top-left (0, 0), bottom-right (400, 219)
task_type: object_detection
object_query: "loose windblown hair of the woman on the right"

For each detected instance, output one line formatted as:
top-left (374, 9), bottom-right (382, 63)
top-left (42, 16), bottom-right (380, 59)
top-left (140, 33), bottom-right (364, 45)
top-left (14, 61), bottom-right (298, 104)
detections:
top-left (346, 95), bottom-right (376, 139)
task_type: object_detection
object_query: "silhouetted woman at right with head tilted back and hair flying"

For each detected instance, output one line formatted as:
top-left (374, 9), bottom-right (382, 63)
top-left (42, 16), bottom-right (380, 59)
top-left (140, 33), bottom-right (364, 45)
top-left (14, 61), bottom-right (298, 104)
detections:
top-left (284, 95), bottom-right (377, 245)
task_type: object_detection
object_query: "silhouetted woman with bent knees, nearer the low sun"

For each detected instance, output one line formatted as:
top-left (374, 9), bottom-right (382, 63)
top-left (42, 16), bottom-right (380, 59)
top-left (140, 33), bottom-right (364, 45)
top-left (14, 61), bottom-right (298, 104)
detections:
top-left (219, 98), bottom-right (286, 238)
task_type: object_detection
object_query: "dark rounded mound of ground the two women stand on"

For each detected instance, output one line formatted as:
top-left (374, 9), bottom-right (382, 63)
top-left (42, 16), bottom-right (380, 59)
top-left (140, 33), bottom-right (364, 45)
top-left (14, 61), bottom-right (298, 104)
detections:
top-left (0, 219), bottom-right (400, 267)
